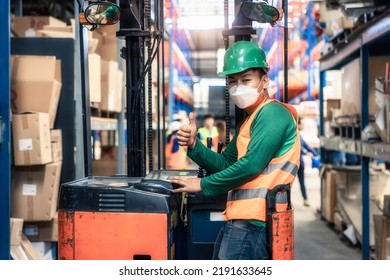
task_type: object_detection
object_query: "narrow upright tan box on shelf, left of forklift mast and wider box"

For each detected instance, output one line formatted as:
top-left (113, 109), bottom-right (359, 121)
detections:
top-left (88, 53), bottom-right (102, 102)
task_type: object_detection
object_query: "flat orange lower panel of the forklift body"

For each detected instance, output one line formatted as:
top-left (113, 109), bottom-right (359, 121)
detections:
top-left (58, 211), bottom-right (174, 260)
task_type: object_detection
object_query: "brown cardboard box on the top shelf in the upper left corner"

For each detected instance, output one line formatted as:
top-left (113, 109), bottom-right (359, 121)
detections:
top-left (12, 16), bottom-right (66, 37)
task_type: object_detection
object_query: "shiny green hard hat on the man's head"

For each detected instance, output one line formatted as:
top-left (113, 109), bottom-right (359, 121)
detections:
top-left (218, 41), bottom-right (269, 76)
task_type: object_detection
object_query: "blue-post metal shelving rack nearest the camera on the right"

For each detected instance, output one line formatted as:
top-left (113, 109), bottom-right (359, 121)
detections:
top-left (320, 11), bottom-right (390, 260)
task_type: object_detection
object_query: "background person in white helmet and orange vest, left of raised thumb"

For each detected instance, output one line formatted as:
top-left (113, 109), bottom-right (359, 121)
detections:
top-left (165, 120), bottom-right (188, 170)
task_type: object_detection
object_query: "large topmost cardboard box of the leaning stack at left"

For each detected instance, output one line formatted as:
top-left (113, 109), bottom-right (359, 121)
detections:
top-left (11, 55), bottom-right (62, 128)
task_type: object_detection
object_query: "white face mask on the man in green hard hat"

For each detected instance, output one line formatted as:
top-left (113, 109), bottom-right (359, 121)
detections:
top-left (229, 81), bottom-right (263, 109)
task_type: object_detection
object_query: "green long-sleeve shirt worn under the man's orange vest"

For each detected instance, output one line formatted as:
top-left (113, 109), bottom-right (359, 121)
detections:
top-left (187, 102), bottom-right (297, 196)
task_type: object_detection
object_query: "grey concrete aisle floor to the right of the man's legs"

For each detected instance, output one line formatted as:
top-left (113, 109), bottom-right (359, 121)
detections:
top-left (292, 170), bottom-right (362, 260)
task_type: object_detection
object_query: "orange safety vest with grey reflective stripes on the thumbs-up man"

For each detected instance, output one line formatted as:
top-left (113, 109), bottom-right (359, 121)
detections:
top-left (223, 100), bottom-right (300, 222)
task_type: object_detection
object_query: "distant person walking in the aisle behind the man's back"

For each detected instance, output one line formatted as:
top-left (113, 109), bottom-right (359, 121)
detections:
top-left (298, 119), bottom-right (318, 206)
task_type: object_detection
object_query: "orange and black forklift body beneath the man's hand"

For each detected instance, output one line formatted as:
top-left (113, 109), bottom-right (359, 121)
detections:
top-left (58, 177), bottom-right (178, 260)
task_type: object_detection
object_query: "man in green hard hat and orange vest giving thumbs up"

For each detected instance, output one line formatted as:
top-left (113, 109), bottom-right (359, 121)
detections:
top-left (171, 41), bottom-right (300, 260)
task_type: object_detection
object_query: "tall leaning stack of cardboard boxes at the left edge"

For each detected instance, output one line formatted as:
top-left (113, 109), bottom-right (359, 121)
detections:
top-left (11, 53), bottom-right (62, 255)
